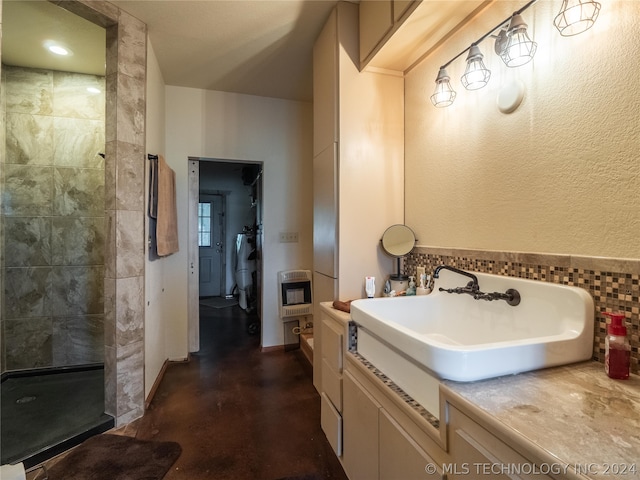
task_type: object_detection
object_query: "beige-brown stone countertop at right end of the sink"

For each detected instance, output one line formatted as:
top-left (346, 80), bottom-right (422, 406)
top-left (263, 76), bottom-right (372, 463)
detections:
top-left (443, 362), bottom-right (640, 478)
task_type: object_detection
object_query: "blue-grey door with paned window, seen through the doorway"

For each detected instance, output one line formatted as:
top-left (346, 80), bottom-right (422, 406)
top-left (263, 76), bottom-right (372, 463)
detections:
top-left (198, 195), bottom-right (224, 297)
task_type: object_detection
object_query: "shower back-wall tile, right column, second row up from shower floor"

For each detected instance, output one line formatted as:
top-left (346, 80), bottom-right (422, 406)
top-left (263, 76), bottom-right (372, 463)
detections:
top-left (51, 266), bottom-right (104, 316)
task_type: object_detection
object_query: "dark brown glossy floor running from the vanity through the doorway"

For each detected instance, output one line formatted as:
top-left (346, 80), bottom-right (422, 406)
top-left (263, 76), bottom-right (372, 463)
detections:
top-left (136, 306), bottom-right (346, 480)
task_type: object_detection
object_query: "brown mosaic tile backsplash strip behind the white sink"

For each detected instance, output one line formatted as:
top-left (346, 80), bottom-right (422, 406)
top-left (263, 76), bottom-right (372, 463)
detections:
top-left (404, 247), bottom-right (640, 374)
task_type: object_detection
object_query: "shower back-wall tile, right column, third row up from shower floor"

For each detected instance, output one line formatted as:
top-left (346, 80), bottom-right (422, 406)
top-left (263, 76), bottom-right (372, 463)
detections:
top-left (51, 217), bottom-right (104, 266)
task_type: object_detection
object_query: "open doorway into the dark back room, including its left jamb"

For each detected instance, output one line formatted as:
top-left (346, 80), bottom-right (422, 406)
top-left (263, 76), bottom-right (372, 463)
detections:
top-left (188, 157), bottom-right (262, 352)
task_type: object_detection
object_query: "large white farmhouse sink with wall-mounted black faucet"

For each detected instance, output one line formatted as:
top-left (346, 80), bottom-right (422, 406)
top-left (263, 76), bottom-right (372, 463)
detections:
top-left (351, 270), bottom-right (594, 386)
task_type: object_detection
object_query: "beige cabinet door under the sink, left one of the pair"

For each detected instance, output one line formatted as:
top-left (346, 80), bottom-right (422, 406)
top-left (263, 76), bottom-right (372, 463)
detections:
top-left (342, 372), bottom-right (380, 480)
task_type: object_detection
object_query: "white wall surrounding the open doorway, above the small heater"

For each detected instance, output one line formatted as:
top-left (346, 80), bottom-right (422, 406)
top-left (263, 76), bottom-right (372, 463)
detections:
top-left (166, 86), bottom-right (313, 348)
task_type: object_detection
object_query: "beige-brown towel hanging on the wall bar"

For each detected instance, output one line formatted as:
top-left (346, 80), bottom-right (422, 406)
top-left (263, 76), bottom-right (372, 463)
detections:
top-left (156, 155), bottom-right (178, 257)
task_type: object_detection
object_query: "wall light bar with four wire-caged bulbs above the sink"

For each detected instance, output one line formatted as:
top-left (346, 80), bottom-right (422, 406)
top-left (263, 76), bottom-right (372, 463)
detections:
top-left (430, 0), bottom-right (600, 107)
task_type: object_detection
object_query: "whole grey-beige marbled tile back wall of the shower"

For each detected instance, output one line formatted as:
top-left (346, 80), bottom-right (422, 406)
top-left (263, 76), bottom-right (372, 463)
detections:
top-left (1, 65), bottom-right (105, 371)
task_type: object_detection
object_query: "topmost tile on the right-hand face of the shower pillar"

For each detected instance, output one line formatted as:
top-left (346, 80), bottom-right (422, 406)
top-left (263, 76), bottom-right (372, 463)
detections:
top-left (118, 12), bottom-right (147, 80)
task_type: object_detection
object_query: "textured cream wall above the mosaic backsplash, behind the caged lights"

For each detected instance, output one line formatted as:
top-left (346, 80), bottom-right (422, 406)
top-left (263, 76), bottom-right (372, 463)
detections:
top-left (405, 0), bottom-right (640, 258)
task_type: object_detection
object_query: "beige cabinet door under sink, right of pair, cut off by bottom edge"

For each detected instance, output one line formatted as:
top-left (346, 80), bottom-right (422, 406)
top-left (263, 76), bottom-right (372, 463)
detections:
top-left (380, 409), bottom-right (442, 480)
